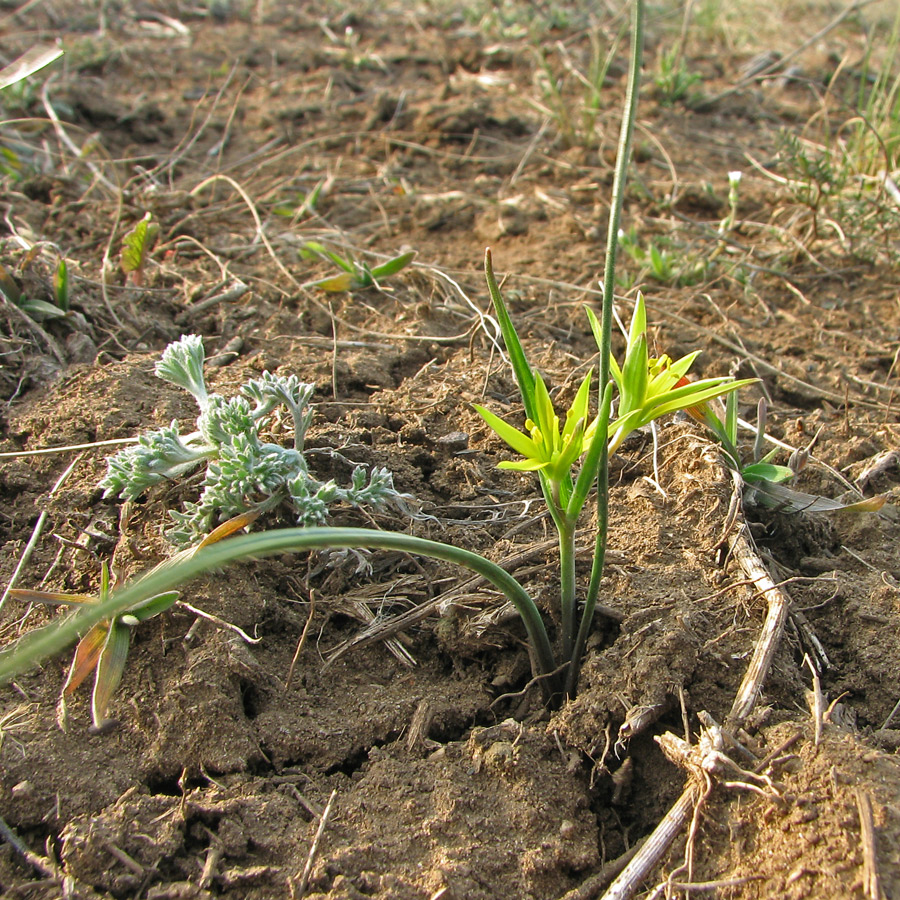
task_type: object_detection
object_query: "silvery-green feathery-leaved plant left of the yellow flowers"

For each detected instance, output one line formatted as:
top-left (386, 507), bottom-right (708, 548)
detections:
top-left (99, 335), bottom-right (401, 546)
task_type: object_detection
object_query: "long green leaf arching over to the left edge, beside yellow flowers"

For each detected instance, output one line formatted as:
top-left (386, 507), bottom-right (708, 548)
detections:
top-left (0, 528), bottom-right (557, 700)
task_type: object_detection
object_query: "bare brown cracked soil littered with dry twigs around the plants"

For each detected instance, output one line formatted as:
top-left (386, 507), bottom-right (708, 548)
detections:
top-left (0, 0), bottom-right (900, 900)
